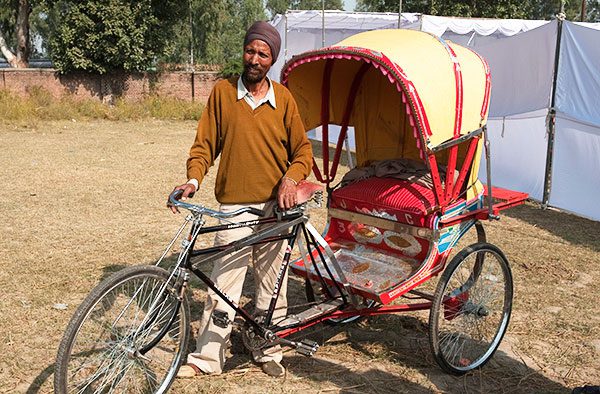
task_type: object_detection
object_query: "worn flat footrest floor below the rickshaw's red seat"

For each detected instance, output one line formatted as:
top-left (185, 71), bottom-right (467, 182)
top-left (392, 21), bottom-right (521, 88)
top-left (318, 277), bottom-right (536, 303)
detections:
top-left (291, 242), bottom-right (421, 304)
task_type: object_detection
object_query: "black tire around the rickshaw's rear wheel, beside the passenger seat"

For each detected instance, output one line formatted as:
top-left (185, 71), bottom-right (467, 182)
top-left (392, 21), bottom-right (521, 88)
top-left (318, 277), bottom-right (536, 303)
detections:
top-left (429, 242), bottom-right (513, 376)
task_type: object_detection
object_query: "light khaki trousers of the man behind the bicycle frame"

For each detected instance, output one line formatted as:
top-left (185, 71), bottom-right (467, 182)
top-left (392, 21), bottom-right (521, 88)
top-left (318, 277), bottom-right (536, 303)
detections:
top-left (187, 201), bottom-right (287, 374)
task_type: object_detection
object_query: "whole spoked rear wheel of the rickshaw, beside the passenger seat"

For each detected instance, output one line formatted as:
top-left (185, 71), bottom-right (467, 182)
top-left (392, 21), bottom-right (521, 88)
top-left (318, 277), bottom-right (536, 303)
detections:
top-left (429, 242), bottom-right (513, 375)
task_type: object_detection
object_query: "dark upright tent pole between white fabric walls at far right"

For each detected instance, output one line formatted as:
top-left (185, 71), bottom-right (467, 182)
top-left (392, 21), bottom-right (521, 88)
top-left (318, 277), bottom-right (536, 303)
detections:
top-left (542, 13), bottom-right (564, 209)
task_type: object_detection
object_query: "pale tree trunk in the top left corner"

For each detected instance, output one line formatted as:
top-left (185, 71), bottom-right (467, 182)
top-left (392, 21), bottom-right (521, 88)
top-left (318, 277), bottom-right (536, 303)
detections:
top-left (0, 0), bottom-right (31, 67)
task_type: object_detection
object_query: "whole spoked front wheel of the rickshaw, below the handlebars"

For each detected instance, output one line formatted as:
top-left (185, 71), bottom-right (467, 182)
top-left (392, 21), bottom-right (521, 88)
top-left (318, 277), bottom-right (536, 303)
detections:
top-left (54, 266), bottom-right (190, 393)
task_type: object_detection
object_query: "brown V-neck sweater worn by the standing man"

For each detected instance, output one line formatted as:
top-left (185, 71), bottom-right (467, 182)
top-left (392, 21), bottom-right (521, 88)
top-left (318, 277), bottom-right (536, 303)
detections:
top-left (187, 77), bottom-right (312, 204)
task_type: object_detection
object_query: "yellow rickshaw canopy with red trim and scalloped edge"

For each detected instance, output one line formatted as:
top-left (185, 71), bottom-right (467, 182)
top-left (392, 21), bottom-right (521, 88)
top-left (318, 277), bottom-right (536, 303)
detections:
top-left (282, 29), bottom-right (489, 164)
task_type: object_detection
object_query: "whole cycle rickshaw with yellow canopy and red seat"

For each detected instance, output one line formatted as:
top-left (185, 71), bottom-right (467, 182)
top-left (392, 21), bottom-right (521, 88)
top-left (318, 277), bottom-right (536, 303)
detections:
top-left (55, 30), bottom-right (527, 393)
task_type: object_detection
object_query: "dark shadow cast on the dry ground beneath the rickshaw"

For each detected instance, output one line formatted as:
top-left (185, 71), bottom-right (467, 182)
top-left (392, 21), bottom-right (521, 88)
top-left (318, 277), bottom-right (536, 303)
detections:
top-left (27, 251), bottom-right (570, 394)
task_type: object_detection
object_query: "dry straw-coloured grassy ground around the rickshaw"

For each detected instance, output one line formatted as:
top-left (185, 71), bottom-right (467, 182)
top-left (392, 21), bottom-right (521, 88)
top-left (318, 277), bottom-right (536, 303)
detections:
top-left (0, 121), bottom-right (600, 393)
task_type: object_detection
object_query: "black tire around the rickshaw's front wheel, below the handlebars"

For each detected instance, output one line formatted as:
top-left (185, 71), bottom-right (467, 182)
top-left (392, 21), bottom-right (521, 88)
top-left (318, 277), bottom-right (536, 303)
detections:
top-left (54, 265), bottom-right (190, 394)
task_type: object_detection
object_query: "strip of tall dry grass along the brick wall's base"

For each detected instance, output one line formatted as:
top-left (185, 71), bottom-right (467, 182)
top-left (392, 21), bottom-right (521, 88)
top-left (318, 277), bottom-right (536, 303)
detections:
top-left (0, 87), bottom-right (204, 125)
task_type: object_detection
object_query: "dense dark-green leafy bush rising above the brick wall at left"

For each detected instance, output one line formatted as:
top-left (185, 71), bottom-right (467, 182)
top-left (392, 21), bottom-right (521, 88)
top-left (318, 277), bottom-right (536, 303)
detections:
top-left (49, 0), bottom-right (186, 74)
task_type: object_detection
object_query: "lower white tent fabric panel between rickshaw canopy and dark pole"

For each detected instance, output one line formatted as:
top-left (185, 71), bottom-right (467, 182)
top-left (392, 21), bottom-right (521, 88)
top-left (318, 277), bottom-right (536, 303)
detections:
top-left (479, 109), bottom-right (548, 201)
